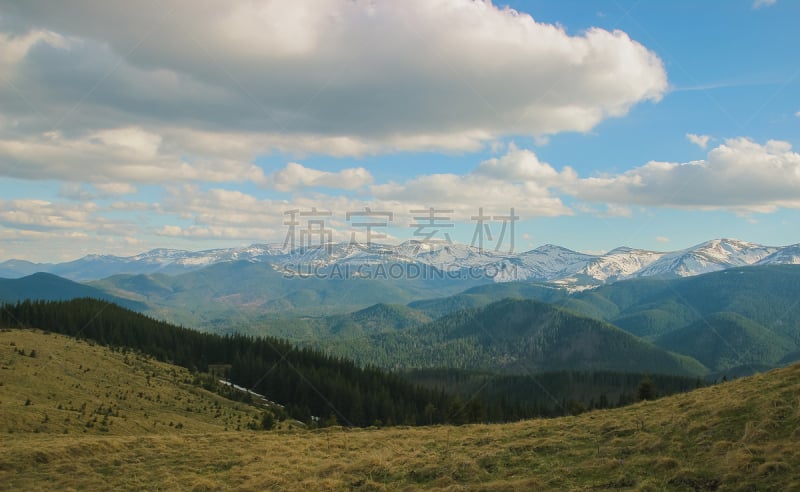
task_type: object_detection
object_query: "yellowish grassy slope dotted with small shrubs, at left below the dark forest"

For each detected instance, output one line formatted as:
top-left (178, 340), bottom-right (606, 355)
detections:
top-left (0, 330), bottom-right (266, 437)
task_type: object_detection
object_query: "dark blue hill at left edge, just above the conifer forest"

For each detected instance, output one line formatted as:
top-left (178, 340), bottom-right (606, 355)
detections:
top-left (0, 273), bottom-right (145, 311)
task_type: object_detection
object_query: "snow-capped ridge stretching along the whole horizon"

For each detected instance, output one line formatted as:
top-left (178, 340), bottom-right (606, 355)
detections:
top-left (0, 239), bottom-right (800, 289)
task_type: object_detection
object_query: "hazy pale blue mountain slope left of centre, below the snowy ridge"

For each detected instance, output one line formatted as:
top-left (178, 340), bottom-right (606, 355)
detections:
top-left (89, 261), bottom-right (470, 330)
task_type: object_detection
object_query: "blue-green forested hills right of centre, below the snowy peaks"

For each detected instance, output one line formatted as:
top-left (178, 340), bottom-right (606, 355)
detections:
top-left (268, 265), bottom-right (800, 378)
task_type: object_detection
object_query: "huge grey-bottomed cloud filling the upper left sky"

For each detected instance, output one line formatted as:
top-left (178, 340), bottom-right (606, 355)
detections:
top-left (0, 0), bottom-right (668, 166)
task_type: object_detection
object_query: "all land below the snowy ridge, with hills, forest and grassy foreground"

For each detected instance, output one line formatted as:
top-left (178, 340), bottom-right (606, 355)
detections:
top-left (0, 240), bottom-right (800, 490)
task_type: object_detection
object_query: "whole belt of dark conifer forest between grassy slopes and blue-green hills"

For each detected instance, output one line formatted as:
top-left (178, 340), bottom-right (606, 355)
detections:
top-left (0, 299), bottom-right (695, 426)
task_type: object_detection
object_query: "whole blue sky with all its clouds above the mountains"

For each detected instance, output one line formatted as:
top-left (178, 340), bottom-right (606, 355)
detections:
top-left (0, 0), bottom-right (800, 262)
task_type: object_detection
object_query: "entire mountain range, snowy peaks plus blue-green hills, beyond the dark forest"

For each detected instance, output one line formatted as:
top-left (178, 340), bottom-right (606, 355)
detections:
top-left (0, 239), bottom-right (800, 375)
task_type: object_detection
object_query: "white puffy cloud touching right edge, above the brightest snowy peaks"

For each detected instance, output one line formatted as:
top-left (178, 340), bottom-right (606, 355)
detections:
top-left (562, 137), bottom-right (800, 213)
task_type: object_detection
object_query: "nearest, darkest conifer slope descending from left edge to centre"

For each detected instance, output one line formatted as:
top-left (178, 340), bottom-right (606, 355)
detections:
top-left (0, 299), bottom-right (468, 426)
